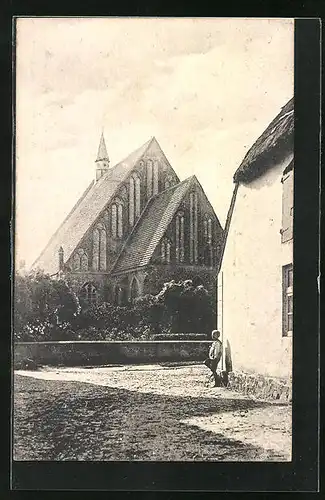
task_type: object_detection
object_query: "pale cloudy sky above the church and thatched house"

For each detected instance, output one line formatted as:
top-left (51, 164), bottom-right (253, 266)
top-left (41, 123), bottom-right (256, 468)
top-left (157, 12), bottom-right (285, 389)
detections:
top-left (15, 18), bottom-right (294, 267)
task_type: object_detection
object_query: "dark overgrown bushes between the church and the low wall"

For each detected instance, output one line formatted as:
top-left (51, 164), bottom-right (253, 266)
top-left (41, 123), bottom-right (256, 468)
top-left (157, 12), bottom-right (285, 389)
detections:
top-left (14, 271), bottom-right (215, 341)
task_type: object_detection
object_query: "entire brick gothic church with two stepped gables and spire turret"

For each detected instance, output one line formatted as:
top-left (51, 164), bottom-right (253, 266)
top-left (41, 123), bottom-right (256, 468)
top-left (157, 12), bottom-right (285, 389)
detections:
top-left (32, 134), bottom-right (223, 305)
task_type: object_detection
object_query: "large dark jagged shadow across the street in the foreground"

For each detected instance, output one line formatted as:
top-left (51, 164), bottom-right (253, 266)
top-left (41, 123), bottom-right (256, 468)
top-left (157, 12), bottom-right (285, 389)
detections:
top-left (14, 375), bottom-right (288, 461)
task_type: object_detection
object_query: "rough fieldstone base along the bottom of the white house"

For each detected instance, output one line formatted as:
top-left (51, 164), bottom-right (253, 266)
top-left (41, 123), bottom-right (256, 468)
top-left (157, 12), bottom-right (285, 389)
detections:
top-left (228, 372), bottom-right (292, 402)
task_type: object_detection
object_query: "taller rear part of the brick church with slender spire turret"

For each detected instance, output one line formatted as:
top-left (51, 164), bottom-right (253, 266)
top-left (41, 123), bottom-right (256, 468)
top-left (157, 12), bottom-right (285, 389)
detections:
top-left (33, 135), bottom-right (179, 273)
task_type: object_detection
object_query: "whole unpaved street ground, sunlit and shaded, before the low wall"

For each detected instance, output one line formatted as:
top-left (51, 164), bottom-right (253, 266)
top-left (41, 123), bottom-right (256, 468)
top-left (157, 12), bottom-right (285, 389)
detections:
top-left (14, 365), bottom-right (291, 461)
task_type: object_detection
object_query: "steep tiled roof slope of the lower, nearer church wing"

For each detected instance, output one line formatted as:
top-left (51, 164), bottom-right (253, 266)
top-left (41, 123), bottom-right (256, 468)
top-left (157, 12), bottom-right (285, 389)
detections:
top-left (112, 175), bottom-right (220, 274)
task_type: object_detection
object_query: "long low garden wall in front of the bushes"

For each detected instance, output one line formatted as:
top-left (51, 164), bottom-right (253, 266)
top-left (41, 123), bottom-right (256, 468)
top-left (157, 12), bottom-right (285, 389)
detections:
top-left (14, 340), bottom-right (211, 368)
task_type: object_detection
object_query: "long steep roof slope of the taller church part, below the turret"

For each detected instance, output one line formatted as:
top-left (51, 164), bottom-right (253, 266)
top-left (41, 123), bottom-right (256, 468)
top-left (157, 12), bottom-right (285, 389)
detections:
top-left (32, 138), bottom-right (155, 274)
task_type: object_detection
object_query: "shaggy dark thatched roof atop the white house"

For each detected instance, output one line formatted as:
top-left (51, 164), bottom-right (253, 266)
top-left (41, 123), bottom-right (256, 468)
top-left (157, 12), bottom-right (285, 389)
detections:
top-left (234, 98), bottom-right (294, 183)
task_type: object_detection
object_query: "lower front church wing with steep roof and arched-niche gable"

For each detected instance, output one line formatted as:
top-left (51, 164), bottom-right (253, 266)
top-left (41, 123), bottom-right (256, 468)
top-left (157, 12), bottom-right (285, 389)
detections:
top-left (113, 176), bottom-right (223, 273)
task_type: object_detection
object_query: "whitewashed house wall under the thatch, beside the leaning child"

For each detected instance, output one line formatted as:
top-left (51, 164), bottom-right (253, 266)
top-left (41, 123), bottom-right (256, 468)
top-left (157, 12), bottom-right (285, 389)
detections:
top-left (218, 157), bottom-right (292, 377)
